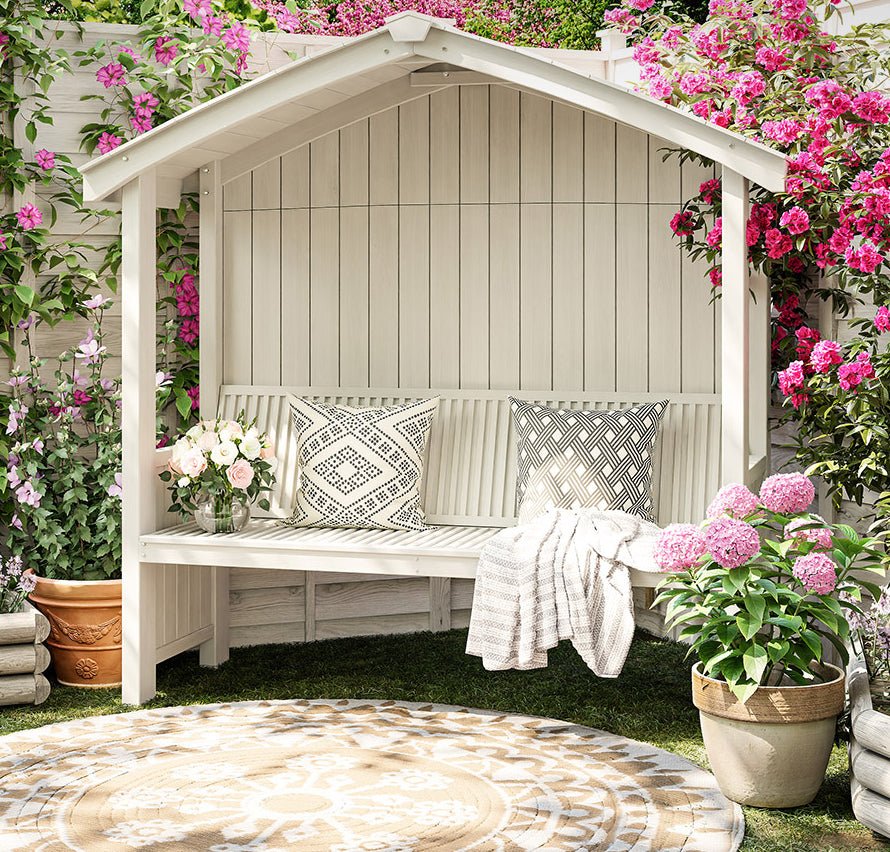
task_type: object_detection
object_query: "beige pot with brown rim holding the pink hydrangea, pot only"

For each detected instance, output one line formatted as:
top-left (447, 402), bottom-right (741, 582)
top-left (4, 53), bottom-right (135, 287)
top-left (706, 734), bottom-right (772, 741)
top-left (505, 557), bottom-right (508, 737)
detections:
top-left (692, 663), bottom-right (845, 808)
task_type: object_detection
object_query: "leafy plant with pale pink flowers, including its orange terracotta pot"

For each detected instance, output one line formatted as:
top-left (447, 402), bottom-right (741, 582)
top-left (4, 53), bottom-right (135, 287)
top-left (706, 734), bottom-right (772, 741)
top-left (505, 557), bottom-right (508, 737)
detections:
top-left (7, 295), bottom-right (122, 687)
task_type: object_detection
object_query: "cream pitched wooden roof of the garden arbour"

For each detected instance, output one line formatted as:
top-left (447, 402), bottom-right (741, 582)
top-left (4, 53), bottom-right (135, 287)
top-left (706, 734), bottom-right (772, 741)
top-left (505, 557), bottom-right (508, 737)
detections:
top-left (81, 12), bottom-right (786, 202)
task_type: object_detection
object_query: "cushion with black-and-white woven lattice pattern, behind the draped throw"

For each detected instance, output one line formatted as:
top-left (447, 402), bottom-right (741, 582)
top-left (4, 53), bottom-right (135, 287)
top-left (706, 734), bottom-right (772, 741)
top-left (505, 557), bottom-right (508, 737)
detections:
top-left (510, 397), bottom-right (667, 524)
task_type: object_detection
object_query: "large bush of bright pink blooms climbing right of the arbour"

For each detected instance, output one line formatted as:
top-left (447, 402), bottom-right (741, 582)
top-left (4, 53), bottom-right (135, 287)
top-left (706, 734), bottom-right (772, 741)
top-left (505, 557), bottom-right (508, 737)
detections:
top-left (606, 0), bottom-right (890, 515)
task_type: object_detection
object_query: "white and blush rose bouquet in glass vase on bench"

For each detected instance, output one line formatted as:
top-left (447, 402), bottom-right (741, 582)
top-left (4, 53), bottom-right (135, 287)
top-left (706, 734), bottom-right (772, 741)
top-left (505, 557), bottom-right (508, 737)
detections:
top-left (160, 412), bottom-right (276, 532)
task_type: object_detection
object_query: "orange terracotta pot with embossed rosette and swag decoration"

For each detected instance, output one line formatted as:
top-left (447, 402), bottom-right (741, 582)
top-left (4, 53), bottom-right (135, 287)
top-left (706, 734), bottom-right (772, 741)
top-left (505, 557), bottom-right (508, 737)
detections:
top-left (30, 577), bottom-right (122, 688)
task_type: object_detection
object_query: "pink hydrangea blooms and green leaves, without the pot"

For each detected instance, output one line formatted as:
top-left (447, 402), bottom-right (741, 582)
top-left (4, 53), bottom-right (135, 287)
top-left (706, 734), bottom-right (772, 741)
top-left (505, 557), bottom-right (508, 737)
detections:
top-left (654, 473), bottom-right (887, 702)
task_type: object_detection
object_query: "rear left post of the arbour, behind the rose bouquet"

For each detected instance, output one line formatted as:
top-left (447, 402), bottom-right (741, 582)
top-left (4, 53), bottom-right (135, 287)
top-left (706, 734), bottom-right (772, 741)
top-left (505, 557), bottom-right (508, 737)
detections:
top-left (198, 160), bottom-right (229, 666)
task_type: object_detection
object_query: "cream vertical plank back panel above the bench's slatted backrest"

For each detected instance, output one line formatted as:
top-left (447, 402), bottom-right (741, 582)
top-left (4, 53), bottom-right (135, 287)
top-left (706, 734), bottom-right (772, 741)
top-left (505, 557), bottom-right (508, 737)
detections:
top-left (223, 85), bottom-right (719, 400)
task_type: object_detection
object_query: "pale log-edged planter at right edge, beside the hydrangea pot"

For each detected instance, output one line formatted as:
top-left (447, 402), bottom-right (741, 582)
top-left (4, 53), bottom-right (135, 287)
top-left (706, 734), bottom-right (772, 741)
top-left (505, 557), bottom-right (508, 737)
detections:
top-left (847, 654), bottom-right (890, 837)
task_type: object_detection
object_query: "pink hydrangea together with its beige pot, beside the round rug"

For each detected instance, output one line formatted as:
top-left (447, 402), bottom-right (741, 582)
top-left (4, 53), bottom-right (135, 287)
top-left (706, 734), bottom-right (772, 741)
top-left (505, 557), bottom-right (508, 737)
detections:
top-left (656, 473), bottom-right (885, 808)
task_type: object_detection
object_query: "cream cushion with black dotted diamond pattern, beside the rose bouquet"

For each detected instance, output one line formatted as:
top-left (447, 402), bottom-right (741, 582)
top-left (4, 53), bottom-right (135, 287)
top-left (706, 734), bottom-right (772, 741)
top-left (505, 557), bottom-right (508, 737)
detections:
top-left (284, 397), bottom-right (439, 530)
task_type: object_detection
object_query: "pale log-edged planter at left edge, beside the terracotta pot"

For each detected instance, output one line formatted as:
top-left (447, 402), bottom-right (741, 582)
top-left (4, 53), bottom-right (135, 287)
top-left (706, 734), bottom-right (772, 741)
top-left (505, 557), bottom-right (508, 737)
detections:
top-left (0, 602), bottom-right (49, 707)
